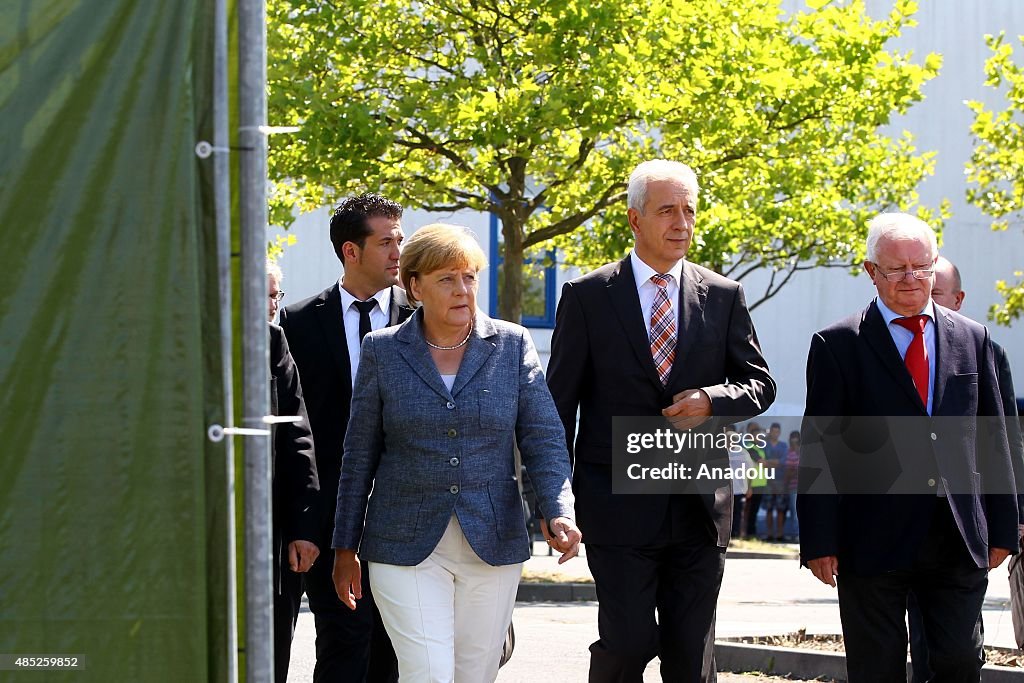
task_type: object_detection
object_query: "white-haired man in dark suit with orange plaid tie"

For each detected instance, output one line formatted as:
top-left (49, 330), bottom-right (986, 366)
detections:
top-left (548, 160), bottom-right (775, 683)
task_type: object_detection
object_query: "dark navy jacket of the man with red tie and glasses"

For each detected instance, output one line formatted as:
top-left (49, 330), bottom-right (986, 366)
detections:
top-left (797, 302), bottom-right (1017, 575)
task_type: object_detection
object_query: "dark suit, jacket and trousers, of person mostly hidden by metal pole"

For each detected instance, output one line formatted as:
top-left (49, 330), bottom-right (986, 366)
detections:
top-left (268, 323), bottom-right (317, 683)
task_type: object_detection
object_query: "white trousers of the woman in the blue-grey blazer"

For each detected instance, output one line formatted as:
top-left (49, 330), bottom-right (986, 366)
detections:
top-left (368, 515), bottom-right (522, 683)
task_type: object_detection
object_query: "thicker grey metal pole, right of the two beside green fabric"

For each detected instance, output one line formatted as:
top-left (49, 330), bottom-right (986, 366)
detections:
top-left (239, 0), bottom-right (273, 683)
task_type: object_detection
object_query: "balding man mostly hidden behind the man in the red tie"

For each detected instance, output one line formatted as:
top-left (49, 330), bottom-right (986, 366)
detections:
top-left (907, 256), bottom-right (1024, 683)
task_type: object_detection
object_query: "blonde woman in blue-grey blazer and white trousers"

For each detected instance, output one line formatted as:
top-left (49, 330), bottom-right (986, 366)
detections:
top-left (333, 223), bottom-right (581, 683)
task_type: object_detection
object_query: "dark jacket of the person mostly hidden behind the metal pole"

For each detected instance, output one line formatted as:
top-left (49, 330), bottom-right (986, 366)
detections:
top-left (267, 323), bottom-right (317, 586)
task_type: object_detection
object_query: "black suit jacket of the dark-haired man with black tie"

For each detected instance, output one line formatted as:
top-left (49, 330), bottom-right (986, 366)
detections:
top-left (281, 283), bottom-right (413, 552)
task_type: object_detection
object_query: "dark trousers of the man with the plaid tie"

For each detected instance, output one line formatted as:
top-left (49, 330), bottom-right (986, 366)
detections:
top-left (587, 537), bottom-right (725, 683)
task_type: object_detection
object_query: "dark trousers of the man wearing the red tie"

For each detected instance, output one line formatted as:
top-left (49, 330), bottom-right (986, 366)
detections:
top-left (839, 499), bottom-right (988, 683)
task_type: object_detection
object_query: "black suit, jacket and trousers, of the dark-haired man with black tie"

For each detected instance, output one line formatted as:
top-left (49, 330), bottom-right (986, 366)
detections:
top-left (281, 283), bottom-right (413, 683)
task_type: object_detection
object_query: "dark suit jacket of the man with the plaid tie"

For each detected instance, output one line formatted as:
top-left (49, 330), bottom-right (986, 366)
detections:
top-left (548, 257), bottom-right (775, 547)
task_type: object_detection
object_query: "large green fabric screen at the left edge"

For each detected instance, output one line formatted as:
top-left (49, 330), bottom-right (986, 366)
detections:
top-left (0, 0), bottom-right (227, 681)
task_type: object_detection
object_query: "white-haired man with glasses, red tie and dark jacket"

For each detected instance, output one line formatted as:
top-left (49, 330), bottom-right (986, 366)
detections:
top-left (797, 214), bottom-right (1018, 683)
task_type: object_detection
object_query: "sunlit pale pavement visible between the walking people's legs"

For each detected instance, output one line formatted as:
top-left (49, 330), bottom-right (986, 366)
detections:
top-left (289, 555), bottom-right (1014, 683)
